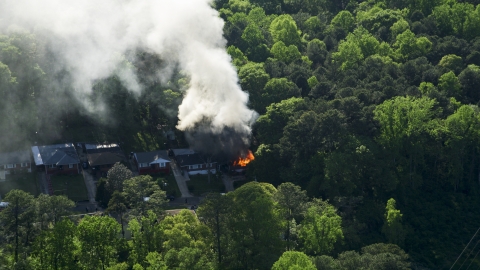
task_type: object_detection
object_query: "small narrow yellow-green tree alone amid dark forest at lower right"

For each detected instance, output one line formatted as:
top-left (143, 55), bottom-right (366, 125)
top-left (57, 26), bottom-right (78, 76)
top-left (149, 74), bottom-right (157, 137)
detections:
top-left (382, 198), bottom-right (405, 246)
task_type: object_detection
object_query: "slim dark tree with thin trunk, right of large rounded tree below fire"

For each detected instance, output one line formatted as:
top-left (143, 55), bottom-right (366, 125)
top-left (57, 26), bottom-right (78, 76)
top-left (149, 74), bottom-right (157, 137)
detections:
top-left (274, 182), bottom-right (308, 250)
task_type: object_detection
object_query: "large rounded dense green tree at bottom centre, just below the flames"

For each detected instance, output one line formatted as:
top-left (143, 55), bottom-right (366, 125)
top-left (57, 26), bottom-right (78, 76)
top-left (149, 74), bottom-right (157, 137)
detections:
top-left (225, 182), bottom-right (283, 269)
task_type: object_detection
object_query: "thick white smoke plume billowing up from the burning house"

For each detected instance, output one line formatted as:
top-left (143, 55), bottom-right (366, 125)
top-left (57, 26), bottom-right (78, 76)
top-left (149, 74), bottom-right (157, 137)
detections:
top-left (0, 0), bottom-right (257, 150)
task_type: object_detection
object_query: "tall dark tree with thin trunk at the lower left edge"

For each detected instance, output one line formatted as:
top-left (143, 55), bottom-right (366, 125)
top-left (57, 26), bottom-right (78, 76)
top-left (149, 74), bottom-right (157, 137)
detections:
top-left (0, 189), bottom-right (35, 262)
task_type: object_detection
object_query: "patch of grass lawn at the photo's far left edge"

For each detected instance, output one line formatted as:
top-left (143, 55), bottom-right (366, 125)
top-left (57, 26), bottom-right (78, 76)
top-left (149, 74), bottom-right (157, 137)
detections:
top-left (0, 173), bottom-right (40, 198)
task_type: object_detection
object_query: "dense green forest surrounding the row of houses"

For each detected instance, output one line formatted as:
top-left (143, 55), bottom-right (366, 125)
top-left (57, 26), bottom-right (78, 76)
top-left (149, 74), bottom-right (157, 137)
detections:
top-left (0, 0), bottom-right (480, 269)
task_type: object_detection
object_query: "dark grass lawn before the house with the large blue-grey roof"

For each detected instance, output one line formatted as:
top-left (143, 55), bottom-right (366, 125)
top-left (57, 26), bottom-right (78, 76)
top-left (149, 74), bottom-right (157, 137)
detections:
top-left (50, 174), bottom-right (88, 202)
